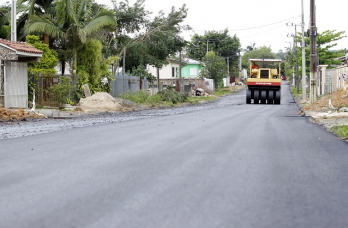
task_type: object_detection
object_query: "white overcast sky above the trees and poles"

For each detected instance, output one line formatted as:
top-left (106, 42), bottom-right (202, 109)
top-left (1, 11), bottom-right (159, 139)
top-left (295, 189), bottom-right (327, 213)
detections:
top-left (96, 0), bottom-right (348, 52)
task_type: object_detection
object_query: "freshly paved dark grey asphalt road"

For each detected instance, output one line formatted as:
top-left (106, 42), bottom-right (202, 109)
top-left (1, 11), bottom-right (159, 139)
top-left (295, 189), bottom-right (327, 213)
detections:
top-left (0, 82), bottom-right (348, 228)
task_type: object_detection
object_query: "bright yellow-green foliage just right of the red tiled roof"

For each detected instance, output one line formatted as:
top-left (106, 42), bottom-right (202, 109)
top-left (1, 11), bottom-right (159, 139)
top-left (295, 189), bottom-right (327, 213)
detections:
top-left (26, 35), bottom-right (58, 75)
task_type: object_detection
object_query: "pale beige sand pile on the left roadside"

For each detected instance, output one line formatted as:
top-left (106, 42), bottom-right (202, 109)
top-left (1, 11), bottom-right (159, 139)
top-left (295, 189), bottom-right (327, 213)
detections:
top-left (80, 92), bottom-right (139, 112)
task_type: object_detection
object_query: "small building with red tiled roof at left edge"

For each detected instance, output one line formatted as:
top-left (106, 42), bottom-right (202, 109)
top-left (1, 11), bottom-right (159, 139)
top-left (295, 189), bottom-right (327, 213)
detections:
top-left (0, 39), bottom-right (43, 108)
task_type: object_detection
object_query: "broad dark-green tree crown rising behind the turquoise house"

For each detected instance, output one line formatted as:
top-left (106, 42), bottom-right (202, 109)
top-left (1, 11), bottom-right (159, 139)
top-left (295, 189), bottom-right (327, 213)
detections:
top-left (187, 29), bottom-right (241, 75)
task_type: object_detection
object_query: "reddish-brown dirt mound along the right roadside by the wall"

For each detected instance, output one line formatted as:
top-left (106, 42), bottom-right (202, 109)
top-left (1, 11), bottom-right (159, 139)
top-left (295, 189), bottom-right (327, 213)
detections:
top-left (302, 89), bottom-right (348, 112)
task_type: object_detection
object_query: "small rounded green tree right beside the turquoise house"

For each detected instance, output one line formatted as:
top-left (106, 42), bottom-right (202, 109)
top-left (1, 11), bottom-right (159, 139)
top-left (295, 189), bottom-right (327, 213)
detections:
top-left (200, 51), bottom-right (227, 89)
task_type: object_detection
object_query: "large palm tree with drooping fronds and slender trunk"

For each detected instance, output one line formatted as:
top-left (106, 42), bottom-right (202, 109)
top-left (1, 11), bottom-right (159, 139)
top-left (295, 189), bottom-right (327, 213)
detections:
top-left (25, 0), bottom-right (116, 80)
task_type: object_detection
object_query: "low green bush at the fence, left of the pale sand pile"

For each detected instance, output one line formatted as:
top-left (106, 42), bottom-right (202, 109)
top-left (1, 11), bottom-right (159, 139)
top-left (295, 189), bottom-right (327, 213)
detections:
top-left (48, 77), bottom-right (74, 108)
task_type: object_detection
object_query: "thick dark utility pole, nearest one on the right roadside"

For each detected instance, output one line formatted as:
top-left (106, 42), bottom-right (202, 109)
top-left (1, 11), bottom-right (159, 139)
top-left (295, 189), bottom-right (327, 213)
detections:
top-left (310, 0), bottom-right (317, 103)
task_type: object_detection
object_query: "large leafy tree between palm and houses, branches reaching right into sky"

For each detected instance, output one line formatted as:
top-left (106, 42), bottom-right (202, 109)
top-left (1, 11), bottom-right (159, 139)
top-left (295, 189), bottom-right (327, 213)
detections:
top-left (114, 5), bottom-right (189, 75)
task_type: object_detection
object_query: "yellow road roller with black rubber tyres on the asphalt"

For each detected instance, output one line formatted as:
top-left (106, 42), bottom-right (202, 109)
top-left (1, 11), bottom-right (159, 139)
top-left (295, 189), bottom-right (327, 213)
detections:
top-left (246, 59), bottom-right (282, 104)
